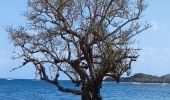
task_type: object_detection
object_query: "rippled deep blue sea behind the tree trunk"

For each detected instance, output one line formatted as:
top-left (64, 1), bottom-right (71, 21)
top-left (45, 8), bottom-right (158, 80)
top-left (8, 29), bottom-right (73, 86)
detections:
top-left (0, 79), bottom-right (170, 100)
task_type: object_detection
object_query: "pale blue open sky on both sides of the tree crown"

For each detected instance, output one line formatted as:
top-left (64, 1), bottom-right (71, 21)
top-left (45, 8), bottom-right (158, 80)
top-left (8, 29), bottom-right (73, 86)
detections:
top-left (0, 0), bottom-right (170, 78)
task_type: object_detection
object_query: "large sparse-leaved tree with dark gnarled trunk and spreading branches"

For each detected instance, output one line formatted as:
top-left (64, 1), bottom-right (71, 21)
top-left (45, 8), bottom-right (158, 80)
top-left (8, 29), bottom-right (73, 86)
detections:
top-left (6, 0), bottom-right (150, 100)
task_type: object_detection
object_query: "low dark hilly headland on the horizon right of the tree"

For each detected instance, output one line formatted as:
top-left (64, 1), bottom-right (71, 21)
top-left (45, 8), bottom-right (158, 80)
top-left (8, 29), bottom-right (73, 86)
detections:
top-left (105, 73), bottom-right (170, 83)
